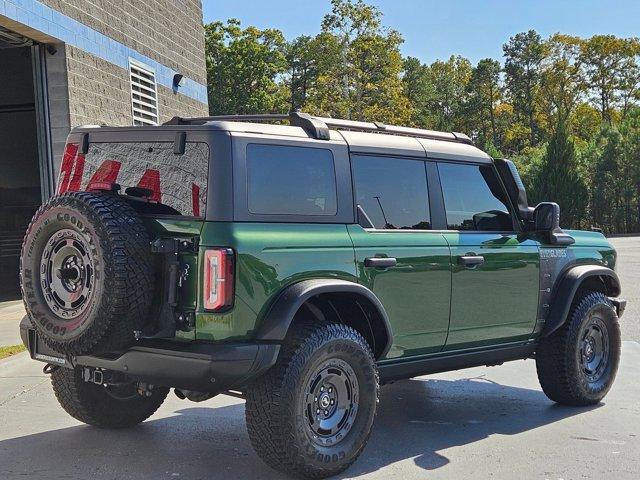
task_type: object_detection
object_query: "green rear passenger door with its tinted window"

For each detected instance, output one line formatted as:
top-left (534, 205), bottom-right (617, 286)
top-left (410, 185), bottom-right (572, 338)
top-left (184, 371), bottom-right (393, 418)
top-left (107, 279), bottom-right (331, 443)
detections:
top-left (349, 155), bottom-right (451, 358)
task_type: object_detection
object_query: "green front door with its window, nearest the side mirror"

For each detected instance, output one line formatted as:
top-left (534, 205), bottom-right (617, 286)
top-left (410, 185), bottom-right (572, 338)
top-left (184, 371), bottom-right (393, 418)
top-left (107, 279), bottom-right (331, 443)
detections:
top-left (438, 160), bottom-right (540, 350)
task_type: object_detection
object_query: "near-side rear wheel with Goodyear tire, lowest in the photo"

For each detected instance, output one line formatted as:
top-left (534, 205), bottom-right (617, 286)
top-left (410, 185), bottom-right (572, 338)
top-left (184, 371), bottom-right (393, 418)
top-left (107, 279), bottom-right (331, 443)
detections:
top-left (246, 324), bottom-right (379, 478)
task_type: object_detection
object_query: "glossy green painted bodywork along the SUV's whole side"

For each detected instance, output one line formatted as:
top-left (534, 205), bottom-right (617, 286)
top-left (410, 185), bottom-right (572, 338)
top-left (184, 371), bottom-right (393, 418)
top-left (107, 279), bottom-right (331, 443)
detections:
top-left (144, 219), bottom-right (615, 361)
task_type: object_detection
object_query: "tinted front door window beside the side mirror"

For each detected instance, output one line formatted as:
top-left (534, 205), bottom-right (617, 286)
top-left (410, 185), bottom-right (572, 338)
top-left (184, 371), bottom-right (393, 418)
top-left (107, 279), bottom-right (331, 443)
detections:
top-left (438, 163), bottom-right (513, 231)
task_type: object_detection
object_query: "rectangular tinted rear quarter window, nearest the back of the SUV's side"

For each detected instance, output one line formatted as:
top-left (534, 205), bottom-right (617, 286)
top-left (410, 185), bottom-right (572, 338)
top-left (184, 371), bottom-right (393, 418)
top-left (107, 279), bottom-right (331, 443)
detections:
top-left (247, 144), bottom-right (338, 215)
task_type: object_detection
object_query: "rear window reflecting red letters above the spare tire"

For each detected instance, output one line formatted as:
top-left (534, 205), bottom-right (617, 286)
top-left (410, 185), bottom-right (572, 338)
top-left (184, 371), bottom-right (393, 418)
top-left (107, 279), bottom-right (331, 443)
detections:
top-left (57, 142), bottom-right (209, 217)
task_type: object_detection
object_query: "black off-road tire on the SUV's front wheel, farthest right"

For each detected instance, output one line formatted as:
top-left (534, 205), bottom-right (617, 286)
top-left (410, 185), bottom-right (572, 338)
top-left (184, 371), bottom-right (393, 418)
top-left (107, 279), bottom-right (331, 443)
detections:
top-left (536, 291), bottom-right (620, 406)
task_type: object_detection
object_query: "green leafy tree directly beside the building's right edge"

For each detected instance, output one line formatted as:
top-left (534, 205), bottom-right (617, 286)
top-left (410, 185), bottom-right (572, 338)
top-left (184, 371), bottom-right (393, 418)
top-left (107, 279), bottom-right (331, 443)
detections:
top-left (205, 19), bottom-right (286, 115)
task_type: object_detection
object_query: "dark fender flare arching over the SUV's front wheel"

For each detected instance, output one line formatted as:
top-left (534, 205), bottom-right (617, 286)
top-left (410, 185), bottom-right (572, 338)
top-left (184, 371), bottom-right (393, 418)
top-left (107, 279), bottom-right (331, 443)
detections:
top-left (542, 265), bottom-right (620, 337)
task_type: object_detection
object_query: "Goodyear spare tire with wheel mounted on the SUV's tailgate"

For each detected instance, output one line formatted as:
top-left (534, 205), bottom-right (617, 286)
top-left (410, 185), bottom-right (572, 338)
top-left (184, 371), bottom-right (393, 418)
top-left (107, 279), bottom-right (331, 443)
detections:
top-left (20, 192), bottom-right (154, 355)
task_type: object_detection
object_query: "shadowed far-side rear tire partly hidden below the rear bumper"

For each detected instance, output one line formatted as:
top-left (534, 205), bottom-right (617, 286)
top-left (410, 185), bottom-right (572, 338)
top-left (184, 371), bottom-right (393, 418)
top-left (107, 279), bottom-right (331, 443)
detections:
top-left (51, 368), bottom-right (169, 428)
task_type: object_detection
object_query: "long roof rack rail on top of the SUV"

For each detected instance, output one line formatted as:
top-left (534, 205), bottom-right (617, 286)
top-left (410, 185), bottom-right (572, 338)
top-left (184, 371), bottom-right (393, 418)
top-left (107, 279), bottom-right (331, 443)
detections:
top-left (164, 111), bottom-right (473, 145)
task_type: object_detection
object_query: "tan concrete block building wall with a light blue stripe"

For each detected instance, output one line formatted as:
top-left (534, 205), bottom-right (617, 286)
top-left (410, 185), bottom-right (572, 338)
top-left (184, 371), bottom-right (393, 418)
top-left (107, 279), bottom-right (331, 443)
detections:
top-left (0, 0), bottom-right (208, 128)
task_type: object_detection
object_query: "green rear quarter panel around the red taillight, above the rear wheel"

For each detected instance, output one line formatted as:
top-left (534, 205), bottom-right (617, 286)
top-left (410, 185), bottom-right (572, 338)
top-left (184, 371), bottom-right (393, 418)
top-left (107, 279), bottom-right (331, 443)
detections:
top-left (196, 222), bottom-right (357, 341)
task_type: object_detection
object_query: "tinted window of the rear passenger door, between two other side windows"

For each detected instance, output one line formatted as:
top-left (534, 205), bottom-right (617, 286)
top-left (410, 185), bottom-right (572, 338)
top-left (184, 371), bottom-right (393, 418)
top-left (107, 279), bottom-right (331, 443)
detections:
top-left (352, 156), bottom-right (431, 230)
